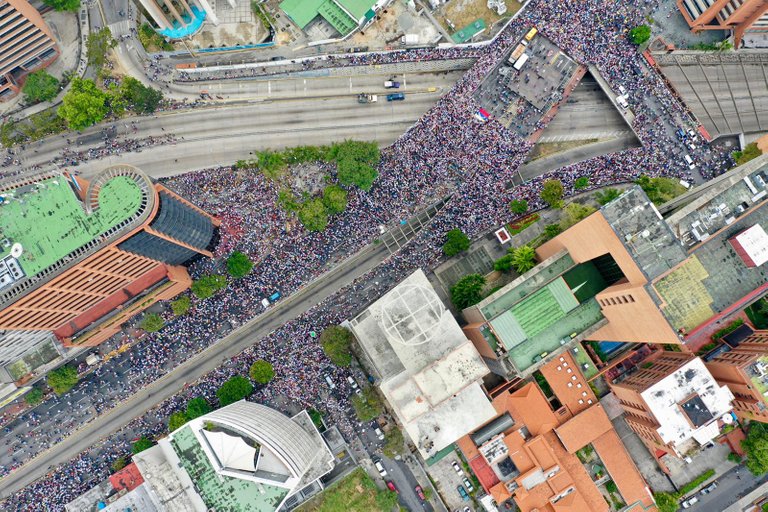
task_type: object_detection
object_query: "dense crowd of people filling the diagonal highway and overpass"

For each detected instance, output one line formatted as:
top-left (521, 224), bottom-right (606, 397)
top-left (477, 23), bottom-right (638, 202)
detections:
top-left (0, 0), bottom-right (731, 511)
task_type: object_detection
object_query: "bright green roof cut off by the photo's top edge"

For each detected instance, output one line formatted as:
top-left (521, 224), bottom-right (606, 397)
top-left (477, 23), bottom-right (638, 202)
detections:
top-left (280, 0), bottom-right (376, 36)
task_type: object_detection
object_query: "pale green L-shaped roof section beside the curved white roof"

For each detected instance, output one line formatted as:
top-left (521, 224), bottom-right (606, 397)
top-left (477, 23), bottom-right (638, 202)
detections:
top-left (171, 425), bottom-right (288, 512)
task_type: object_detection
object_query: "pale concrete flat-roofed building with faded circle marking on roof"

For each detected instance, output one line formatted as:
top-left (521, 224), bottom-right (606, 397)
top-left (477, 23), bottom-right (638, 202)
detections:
top-left (349, 270), bottom-right (495, 459)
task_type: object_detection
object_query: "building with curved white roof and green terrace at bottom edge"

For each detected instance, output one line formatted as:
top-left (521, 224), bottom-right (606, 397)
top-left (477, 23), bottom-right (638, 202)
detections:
top-left (66, 400), bottom-right (335, 512)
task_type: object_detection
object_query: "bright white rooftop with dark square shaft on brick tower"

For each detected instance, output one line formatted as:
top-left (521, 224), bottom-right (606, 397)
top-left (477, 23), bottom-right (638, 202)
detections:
top-left (641, 357), bottom-right (733, 445)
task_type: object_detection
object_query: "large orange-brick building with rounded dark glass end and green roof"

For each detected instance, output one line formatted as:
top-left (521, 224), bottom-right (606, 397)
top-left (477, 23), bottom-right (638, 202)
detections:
top-left (0, 165), bottom-right (219, 386)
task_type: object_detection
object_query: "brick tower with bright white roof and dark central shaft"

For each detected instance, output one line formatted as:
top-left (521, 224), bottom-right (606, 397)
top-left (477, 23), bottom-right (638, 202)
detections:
top-left (611, 351), bottom-right (735, 458)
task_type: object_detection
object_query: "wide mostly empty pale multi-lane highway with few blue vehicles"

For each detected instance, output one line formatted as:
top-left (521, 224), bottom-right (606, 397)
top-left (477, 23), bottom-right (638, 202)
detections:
top-left (19, 71), bottom-right (462, 177)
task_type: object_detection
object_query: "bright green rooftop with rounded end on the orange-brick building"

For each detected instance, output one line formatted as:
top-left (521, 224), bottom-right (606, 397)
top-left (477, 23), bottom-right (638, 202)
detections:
top-left (0, 176), bottom-right (142, 277)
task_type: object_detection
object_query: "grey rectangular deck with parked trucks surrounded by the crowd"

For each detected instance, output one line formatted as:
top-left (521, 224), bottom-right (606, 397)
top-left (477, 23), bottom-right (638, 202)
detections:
top-left (475, 35), bottom-right (578, 137)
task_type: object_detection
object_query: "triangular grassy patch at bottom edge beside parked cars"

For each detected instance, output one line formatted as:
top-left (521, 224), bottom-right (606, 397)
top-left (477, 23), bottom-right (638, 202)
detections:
top-left (296, 468), bottom-right (397, 512)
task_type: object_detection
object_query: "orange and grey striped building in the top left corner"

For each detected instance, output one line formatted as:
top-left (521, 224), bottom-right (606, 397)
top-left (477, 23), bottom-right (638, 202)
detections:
top-left (0, 0), bottom-right (59, 101)
